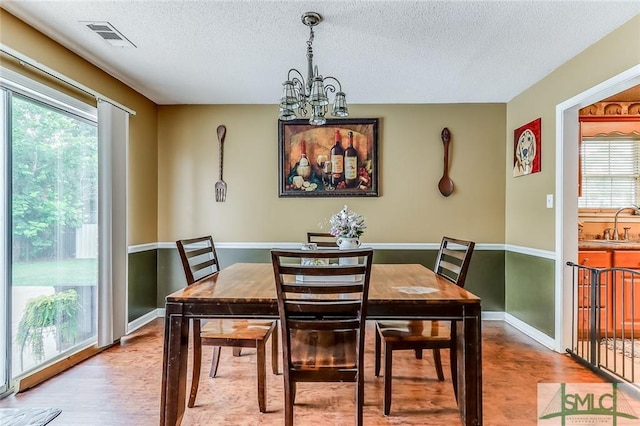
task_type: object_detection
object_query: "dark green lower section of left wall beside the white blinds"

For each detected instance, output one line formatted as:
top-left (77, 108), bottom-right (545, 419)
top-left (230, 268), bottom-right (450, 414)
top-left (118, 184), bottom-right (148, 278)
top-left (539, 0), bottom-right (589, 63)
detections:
top-left (128, 250), bottom-right (158, 322)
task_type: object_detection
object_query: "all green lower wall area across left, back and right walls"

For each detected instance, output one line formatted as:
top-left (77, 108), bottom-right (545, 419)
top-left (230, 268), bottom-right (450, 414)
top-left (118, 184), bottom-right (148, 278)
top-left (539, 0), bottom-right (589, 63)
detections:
top-left (129, 249), bottom-right (555, 338)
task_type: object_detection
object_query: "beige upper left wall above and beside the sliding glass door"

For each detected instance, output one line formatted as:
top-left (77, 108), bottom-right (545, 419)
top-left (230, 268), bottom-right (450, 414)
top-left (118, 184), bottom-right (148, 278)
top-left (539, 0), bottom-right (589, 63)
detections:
top-left (0, 9), bottom-right (158, 244)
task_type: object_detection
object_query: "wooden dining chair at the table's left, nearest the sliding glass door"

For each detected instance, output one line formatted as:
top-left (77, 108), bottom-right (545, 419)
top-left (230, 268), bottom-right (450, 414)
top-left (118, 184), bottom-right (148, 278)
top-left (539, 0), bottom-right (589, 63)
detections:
top-left (176, 236), bottom-right (278, 413)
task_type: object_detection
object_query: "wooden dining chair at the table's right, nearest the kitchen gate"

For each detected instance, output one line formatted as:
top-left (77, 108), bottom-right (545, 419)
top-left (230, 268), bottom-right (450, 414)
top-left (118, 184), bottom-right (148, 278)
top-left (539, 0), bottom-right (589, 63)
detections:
top-left (374, 237), bottom-right (475, 416)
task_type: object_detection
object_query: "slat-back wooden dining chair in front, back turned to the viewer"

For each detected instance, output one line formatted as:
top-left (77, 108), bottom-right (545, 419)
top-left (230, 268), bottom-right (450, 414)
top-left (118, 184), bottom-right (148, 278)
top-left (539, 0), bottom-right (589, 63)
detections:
top-left (271, 249), bottom-right (373, 426)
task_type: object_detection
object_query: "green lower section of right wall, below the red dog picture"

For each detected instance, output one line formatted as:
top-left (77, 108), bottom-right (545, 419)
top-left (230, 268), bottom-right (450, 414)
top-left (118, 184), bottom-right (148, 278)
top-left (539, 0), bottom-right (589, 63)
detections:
top-left (504, 251), bottom-right (555, 338)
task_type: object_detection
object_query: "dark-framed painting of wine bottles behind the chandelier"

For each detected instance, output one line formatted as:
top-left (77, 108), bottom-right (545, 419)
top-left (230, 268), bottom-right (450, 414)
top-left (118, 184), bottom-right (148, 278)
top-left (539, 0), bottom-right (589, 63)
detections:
top-left (278, 118), bottom-right (379, 197)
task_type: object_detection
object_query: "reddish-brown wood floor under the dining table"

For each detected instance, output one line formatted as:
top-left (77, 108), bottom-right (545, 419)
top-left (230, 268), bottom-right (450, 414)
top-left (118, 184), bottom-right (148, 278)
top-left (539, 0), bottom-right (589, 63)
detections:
top-left (0, 320), bottom-right (604, 426)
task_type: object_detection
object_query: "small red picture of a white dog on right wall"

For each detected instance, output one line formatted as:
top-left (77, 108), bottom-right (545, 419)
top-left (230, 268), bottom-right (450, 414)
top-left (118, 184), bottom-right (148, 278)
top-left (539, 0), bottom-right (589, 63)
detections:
top-left (513, 118), bottom-right (542, 177)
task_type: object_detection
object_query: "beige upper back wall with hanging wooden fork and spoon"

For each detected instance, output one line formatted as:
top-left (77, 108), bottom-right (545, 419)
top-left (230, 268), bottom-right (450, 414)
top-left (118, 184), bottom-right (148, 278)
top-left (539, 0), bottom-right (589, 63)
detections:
top-left (158, 104), bottom-right (505, 243)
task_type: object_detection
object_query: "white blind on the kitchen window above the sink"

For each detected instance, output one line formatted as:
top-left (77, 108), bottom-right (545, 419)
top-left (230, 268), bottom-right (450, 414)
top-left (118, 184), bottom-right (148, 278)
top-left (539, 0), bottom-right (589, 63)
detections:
top-left (578, 139), bottom-right (640, 208)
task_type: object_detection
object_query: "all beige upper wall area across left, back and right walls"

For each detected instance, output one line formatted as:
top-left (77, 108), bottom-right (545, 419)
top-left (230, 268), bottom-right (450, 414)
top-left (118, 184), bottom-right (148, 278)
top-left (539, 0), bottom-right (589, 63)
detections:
top-left (0, 9), bottom-right (640, 250)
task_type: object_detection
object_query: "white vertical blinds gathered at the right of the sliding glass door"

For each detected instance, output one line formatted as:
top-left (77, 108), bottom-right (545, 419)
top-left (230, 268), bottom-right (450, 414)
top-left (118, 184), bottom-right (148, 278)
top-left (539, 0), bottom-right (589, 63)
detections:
top-left (98, 101), bottom-right (129, 347)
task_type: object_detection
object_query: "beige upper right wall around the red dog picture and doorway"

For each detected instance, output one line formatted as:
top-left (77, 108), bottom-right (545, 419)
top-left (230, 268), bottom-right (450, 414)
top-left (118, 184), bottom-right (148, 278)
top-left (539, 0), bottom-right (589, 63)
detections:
top-left (505, 16), bottom-right (640, 250)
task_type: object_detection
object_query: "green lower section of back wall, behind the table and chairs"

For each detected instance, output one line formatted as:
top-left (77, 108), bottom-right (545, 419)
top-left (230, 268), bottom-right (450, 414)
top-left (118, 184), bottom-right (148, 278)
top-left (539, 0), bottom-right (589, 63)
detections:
top-left (152, 249), bottom-right (505, 312)
